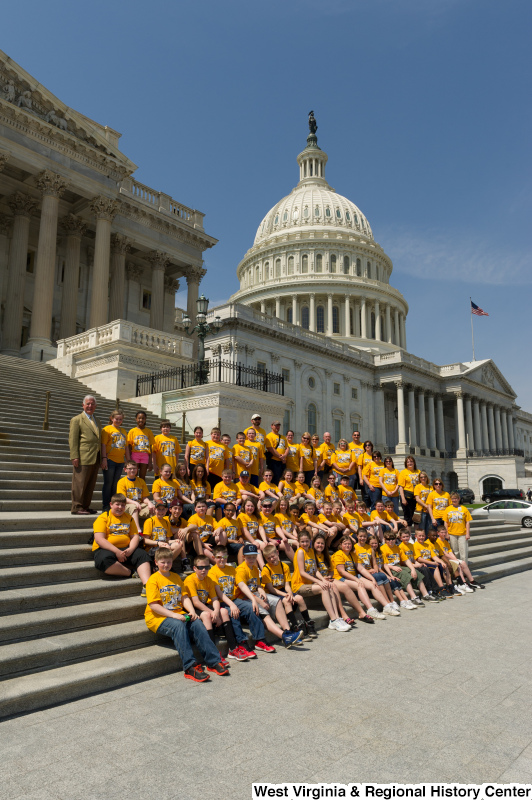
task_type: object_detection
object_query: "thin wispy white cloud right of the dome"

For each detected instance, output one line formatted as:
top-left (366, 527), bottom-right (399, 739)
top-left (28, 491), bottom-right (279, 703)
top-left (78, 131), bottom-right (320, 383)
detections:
top-left (379, 228), bottom-right (532, 285)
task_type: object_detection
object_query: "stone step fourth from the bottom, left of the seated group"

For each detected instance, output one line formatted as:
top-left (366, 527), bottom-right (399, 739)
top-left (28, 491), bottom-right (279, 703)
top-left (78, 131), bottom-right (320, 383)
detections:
top-left (0, 576), bottom-right (142, 616)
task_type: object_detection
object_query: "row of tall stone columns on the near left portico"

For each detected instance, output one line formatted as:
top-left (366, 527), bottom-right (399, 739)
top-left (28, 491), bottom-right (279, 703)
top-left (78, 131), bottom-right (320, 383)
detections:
top-left (2, 170), bottom-right (204, 355)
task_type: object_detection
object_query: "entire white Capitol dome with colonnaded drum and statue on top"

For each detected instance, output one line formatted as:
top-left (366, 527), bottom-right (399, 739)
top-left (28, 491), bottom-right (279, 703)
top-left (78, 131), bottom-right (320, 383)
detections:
top-left (231, 118), bottom-right (408, 352)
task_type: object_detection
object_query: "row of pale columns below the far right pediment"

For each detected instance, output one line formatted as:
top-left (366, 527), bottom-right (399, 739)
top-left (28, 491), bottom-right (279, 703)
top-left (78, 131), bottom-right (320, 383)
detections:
top-left (396, 381), bottom-right (515, 453)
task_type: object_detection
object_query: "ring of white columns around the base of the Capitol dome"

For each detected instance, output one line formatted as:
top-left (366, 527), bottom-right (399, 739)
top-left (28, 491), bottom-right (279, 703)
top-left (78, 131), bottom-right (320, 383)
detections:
top-left (260, 293), bottom-right (406, 350)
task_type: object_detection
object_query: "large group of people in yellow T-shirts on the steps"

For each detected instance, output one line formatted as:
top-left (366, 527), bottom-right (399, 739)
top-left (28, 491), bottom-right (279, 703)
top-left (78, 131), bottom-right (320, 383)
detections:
top-left (93, 411), bottom-right (484, 682)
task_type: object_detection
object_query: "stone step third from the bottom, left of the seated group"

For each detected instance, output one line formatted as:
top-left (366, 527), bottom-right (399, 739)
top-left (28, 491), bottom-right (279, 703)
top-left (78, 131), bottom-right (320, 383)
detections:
top-left (0, 582), bottom-right (146, 644)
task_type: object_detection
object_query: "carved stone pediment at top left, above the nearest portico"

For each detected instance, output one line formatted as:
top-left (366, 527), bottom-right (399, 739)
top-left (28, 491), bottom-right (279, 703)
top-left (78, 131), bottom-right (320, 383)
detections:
top-left (0, 50), bottom-right (136, 175)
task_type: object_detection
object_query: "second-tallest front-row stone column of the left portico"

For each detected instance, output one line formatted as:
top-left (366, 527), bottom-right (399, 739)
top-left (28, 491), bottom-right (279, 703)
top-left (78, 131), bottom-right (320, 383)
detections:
top-left (89, 195), bottom-right (118, 328)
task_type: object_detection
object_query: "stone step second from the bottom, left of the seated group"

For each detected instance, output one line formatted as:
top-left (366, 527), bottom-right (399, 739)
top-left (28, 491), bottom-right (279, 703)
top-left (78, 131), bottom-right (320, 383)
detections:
top-left (0, 619), bottom-right (154, 680)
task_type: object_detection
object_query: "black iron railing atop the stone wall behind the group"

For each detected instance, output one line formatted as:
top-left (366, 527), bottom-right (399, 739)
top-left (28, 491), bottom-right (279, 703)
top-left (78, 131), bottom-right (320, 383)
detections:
top-left (136, 359), bottom-right (284, 397)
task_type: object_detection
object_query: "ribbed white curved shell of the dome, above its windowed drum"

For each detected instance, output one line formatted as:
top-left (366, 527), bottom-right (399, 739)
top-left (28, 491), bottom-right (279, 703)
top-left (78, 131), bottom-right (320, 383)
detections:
top-left (253, 186), bottom-right (373, 246)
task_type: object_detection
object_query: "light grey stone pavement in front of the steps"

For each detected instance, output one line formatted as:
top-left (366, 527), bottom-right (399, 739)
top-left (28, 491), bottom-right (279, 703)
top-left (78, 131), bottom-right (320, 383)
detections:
top-left (0, 573), bottom-right (532, 800)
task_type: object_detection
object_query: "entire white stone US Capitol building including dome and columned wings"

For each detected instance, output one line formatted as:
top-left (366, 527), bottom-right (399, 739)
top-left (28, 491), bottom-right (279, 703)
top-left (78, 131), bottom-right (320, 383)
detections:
top-left (0, 51), bottom-right (532, 497)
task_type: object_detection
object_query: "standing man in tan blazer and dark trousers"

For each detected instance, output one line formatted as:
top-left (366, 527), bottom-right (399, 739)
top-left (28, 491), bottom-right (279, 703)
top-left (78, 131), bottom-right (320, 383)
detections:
top-left (68, 394), bottom-right (102, 514)
